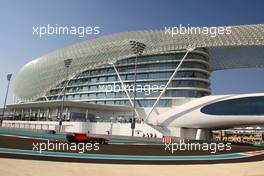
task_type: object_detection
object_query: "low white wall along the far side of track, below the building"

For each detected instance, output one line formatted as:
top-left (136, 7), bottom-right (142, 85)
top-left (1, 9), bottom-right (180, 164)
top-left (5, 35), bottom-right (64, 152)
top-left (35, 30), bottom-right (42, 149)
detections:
top-left (2, 120), bottom-right (163, 138)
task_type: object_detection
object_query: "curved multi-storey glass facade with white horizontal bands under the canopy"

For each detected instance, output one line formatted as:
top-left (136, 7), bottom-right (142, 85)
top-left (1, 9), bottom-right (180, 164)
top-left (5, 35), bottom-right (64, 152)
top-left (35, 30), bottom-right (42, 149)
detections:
top-left (41, 50), bottom-right (210, 107)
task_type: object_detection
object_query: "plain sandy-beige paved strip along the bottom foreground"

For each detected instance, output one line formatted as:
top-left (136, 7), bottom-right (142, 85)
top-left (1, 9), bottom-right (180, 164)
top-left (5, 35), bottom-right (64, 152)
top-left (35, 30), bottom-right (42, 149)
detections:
top-left (0, 158), bottom-right (264, 176)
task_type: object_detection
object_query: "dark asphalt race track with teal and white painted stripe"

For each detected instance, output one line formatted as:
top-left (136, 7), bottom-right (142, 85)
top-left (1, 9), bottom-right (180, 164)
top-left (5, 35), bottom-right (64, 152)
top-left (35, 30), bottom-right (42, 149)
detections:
top-left (0, 136), bottom-right (264, 164)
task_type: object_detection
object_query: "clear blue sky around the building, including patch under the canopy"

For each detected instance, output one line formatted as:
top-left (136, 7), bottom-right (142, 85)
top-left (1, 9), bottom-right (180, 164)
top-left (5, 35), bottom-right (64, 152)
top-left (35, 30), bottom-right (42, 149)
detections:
top-left (0, 0), bottom-right (264, 107)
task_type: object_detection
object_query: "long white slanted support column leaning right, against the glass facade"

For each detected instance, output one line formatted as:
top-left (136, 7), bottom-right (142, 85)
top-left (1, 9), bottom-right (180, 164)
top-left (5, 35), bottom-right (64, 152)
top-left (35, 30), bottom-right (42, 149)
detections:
top-left (145, 48), bottom-right (194, 121)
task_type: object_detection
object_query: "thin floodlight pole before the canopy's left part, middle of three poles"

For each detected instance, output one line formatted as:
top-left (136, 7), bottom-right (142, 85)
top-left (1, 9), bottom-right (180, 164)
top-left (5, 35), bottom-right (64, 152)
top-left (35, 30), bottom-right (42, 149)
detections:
top-left (59, 59), bottom-right (72, 131)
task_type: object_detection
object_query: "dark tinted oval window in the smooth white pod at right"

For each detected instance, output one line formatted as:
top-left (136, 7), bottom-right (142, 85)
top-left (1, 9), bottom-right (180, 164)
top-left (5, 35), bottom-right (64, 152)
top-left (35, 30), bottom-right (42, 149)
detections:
top-left (201, 97), bottom-right (264, 115)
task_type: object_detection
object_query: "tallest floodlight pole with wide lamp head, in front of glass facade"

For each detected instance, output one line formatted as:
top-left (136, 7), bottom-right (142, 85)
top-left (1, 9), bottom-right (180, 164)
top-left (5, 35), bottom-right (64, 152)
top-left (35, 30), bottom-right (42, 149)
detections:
top-left (129, 40), bottom-right (146, 136)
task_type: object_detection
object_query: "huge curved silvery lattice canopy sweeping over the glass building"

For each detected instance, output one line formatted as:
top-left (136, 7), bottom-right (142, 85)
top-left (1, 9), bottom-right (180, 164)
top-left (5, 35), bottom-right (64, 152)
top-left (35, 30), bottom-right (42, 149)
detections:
top-left (14, 24), bottom-right (264, 101)
